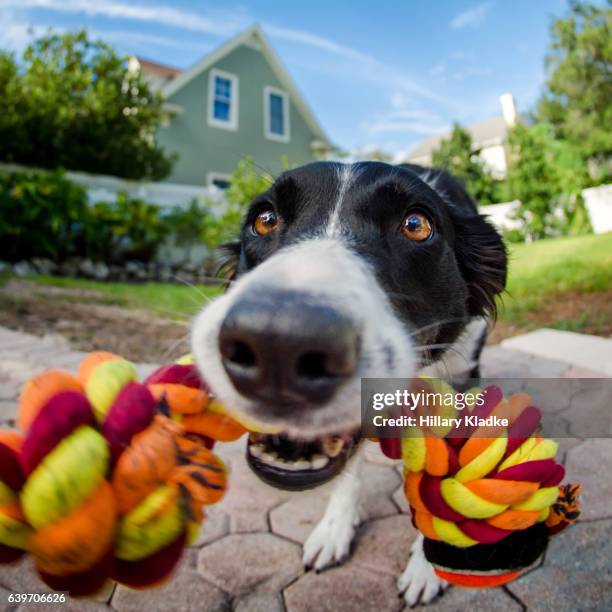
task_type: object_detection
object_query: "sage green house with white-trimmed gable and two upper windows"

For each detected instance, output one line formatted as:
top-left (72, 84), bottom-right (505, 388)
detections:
top-left (132, 25), bottom-right (330, 188)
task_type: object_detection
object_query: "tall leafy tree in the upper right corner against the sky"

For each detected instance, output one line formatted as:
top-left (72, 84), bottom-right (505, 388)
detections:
top-left (536, 0), bottom-right (612, 181)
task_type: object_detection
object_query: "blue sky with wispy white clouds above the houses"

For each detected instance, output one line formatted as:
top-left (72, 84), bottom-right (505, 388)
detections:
top-left (0, 0), bottom-right (567, 153)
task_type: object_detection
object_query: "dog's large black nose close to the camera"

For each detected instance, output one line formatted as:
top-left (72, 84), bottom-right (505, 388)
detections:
top-left (219, 290), bottom-right (360, 405)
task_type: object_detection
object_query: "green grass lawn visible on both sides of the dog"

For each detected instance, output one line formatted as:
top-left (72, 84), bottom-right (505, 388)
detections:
top-left (14, 233), bottom-right (612, 331)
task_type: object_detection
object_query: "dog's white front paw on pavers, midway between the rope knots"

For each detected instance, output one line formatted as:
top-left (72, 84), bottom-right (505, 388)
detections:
top-left (302, 506), bottom-right (360, 571)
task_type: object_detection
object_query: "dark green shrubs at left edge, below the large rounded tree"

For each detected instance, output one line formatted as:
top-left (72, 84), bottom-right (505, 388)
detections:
top-left (0, 172), bottom-right (177, 263)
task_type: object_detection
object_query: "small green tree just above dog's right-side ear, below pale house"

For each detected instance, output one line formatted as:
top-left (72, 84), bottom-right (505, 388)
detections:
top-left (431, 123), bottom-right (497, 204)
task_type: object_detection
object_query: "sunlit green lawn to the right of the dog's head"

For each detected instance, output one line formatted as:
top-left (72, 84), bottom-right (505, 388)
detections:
top-left (500, 233), bottom-right (612, 321)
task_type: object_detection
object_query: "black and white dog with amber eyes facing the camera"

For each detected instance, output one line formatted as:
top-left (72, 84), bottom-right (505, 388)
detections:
top-left (192, 162), bottom-right (506, 605)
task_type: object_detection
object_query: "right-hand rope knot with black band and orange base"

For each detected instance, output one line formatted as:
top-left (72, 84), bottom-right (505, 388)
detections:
top-left (381, 386), bottom-right (580, 588)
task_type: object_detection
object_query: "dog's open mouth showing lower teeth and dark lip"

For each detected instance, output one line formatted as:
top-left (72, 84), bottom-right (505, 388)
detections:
top-left (246, 431), bottom-right (359, 491)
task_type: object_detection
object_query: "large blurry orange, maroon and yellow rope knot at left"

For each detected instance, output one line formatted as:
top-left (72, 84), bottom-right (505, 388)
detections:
top-left (0, 352), bottom-right (244, 596)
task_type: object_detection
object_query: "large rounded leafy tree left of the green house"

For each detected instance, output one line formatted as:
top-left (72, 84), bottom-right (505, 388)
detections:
top-left (0, 31), bottom-right (173, 180)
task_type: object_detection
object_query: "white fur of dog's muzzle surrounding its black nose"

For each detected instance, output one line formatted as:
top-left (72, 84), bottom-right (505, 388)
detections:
top-left (192, 237), bottom-right (416, 437)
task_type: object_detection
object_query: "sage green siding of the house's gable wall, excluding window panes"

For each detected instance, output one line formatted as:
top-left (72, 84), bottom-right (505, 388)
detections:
top-left (158, 25), bottom-right (326, 185)
